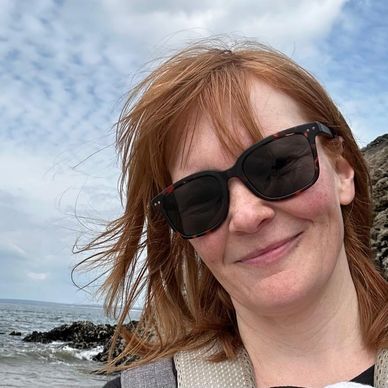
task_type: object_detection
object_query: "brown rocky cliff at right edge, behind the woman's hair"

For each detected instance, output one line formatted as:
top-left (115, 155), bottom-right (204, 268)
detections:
top-left (362, 134), bottom-right (388, 279)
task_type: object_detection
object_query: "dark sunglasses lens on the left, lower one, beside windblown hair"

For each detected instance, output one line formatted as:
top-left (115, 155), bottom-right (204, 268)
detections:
top-left (163, 175), bottom-right (227, 236)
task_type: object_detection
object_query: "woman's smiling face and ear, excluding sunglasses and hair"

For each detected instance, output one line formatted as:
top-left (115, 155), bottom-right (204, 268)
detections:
top-left (171, 81), bottom-right (354, 315)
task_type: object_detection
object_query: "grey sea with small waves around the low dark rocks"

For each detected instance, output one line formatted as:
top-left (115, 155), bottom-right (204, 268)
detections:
top-left (0, 299), bottom-right (140, 388)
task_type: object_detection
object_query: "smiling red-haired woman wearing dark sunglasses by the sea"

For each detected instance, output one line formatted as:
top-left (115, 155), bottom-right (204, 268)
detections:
top-left (83, 42), bottom-right (388, 387)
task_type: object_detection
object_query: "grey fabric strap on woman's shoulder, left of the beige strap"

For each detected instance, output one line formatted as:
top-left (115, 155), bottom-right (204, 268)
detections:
top-left (121, 358), bottom-right (177, 388)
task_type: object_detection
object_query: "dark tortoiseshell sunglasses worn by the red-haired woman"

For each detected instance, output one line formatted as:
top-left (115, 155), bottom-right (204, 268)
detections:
top-left (152, 122), bottom-right (335, 239)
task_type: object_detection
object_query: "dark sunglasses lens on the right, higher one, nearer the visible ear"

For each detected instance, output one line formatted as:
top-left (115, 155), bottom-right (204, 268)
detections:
top-left (243, 134), bottom-right (315, 199)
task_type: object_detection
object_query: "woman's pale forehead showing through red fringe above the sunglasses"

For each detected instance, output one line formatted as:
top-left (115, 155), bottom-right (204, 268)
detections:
top-left (170, 79), bottom-right (308, 181)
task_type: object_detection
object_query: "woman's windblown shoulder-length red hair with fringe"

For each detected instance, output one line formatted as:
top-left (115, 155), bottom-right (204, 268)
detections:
top-left (76, 42), bottom-right (388, 370)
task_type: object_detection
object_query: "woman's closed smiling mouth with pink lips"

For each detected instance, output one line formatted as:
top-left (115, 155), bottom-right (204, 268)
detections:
top-left (238, 232), bottom-right (302, 266)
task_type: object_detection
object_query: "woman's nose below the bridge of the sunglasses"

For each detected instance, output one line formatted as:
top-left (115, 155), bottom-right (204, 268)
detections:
top-left (228, 178), bottom-right (275, 233)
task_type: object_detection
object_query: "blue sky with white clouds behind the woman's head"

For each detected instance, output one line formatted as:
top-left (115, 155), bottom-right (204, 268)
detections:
top-left (0, 0), bottom-right (388, 303)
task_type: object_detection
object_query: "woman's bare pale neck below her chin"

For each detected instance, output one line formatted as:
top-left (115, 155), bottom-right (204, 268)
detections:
top-left (236, 256), bottom-right (375, 387)
